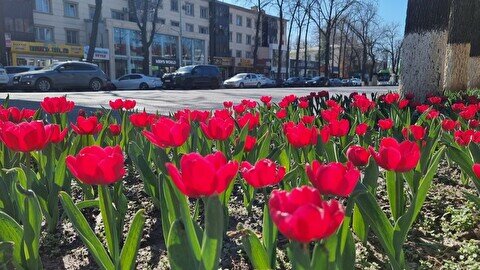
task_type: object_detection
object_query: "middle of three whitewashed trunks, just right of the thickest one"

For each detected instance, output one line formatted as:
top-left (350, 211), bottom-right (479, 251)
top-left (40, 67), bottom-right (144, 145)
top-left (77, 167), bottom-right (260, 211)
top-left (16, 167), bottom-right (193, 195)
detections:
top-left (443, 0), bottom-right (476, 91)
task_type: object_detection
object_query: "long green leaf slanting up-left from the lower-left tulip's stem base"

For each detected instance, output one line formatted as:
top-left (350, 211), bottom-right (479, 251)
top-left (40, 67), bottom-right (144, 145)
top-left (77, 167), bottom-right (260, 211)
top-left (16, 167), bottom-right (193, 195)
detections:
top-left (60, 191), bottom-right (115, 270)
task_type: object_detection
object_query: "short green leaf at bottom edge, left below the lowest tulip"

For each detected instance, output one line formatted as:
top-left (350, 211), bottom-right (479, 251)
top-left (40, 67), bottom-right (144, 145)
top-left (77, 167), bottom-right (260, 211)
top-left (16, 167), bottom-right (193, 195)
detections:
top-left (242, 230), bottom-right (274, 270)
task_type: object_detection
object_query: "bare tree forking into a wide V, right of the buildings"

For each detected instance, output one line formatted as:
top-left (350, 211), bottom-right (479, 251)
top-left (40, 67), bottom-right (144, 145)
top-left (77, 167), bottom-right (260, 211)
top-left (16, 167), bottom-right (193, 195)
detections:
top-left (312, 0), bottom-right (358, 77)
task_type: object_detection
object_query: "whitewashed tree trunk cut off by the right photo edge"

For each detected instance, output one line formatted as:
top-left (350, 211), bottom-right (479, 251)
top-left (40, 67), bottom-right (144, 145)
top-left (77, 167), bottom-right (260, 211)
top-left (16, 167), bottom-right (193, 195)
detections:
top-left (467, 4), bottom-right (480, 89)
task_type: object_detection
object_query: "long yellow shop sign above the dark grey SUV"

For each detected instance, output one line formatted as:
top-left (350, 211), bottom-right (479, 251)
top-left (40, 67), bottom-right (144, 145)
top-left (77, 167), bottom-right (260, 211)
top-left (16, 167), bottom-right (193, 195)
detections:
top-left (12, 41), bottom-right (83, 58)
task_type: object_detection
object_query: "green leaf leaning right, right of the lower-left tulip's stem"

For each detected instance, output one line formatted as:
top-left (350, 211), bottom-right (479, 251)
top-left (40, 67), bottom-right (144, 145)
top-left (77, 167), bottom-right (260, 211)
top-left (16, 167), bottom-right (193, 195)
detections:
top-left (120, 209), bottom-right (145, 270)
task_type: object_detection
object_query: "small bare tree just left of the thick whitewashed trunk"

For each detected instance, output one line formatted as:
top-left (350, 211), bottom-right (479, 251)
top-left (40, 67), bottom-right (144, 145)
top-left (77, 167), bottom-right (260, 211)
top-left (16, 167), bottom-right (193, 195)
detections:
top-left (382, 23), bottom-right (403, 78)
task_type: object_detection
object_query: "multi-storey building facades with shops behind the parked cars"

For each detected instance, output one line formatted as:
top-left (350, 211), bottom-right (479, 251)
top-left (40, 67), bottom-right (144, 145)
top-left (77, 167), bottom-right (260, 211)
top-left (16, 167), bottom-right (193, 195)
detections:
top-left (0, 0), bottom-right (286, 79)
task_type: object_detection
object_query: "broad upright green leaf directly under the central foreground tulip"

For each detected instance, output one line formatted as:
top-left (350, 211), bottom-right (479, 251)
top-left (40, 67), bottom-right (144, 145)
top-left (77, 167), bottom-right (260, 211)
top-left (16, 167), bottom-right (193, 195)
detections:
top-left (200, 196), bottom-right (224, 270)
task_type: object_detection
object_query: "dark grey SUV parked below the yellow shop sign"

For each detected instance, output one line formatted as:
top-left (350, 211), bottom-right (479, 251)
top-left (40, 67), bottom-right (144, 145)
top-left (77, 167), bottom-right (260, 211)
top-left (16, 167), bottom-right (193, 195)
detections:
top-left (13, 61), bottom-right (108, 92)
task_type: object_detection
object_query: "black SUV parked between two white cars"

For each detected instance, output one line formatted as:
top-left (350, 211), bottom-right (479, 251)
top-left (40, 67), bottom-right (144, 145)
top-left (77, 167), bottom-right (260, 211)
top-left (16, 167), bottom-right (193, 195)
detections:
top-left (162, 65), bottom-right (222, 89)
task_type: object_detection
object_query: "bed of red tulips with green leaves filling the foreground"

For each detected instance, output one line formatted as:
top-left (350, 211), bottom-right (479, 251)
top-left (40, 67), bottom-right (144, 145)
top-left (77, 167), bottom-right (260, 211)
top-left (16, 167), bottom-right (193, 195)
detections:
top-left (0, 92), bottom-right (480, 269)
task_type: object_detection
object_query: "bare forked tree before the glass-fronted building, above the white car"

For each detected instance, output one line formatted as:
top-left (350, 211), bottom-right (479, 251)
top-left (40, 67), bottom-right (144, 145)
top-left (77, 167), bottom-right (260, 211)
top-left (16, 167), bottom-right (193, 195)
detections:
top-left (128, 0), bottom-right (161, 75)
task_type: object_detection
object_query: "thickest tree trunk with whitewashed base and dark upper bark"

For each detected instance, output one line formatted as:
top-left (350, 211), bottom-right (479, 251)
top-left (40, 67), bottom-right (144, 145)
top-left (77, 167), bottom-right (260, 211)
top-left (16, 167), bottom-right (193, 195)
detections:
top-left (400, 0), bottom-right (451, 100)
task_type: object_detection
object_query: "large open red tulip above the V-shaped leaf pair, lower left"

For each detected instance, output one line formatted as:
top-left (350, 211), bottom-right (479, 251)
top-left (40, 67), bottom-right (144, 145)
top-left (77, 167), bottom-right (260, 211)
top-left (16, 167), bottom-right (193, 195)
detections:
top-left (65, 145), bottom-right (125, 185)
